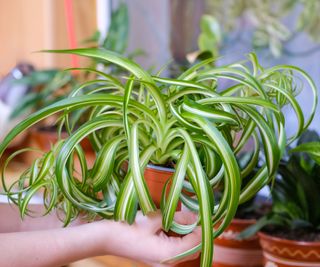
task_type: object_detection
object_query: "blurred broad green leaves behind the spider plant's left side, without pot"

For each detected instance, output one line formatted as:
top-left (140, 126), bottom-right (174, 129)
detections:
top-left (11, 3), bottom-right (131, 124)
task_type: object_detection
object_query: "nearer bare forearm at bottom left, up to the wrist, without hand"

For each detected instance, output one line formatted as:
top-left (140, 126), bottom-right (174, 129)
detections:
top-left (0, 224), bottom-right (105, 267)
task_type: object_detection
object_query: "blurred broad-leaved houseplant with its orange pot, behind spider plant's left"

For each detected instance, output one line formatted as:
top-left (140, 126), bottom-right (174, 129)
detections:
top-left (6, 3), bottom-right (134, 157)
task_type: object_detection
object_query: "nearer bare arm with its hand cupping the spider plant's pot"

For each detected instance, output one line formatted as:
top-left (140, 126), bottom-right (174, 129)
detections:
top-left (0, 208), bottom-right (201, 267)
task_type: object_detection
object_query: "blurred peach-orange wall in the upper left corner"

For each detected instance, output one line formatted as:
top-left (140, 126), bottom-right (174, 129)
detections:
top-left (0, 0), bottom-right (97, 75)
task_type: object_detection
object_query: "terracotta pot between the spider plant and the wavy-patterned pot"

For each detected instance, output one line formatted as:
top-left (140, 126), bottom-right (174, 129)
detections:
top-left (213, 219), bottom-right (263, 267)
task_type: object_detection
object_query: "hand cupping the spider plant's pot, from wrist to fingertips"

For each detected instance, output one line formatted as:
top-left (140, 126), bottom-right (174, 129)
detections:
top-left (95, 211), bottom-right (201, 266)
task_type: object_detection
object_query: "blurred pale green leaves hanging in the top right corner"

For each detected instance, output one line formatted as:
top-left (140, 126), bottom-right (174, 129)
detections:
top-left (206, 0), bottom-right (320, 57)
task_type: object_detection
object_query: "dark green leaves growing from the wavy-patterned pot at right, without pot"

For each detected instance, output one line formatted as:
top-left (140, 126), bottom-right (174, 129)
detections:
top-left (241, 131), bottom-right (320, 240)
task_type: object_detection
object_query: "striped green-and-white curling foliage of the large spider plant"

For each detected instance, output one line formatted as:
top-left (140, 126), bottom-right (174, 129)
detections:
top-left (0, 49), bottom-right (317, 266)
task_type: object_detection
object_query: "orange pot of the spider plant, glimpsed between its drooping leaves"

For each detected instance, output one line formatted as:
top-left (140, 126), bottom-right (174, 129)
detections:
top-left (144, 165), bottom-right (200, 267)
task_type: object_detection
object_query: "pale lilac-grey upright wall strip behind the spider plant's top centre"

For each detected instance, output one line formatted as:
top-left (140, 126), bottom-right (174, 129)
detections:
top-left (113, 0), bottom-right (171, 70)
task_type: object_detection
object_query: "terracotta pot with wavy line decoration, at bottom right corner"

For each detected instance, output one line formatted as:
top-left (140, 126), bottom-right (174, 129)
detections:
top-left (258, 232), bottom-right (320, 267)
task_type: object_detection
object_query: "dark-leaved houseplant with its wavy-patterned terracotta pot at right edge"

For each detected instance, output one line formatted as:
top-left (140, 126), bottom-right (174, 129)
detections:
top-left (241, 131), bottom-right (320, 267)
